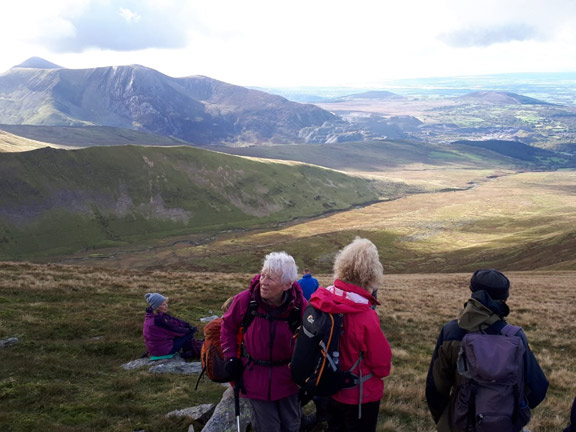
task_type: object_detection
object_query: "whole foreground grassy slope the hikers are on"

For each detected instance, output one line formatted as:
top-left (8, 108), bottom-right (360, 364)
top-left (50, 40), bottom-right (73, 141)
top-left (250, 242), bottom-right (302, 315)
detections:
top-left (0, 263), bottom-right (576, 432)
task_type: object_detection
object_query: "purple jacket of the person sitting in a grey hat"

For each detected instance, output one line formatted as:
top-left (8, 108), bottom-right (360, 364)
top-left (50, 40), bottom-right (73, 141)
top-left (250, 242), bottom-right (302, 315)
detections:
top-left (142, 308), bottom-right (197, 356)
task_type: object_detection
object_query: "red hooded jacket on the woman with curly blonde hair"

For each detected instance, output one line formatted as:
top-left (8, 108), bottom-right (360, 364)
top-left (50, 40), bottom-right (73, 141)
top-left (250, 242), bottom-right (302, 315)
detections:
top-left (310, 279), bottom-right (392, 405)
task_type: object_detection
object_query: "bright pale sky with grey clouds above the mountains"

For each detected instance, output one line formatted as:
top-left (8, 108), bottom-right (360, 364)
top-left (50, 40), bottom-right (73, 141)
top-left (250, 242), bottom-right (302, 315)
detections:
top-left (0, 0), bottom-right (576, 87)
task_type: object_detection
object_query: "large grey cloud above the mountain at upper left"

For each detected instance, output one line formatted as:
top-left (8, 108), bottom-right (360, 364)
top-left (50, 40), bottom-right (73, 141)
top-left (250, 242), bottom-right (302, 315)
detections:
top-left (37, 0), bottom-right (190, 53)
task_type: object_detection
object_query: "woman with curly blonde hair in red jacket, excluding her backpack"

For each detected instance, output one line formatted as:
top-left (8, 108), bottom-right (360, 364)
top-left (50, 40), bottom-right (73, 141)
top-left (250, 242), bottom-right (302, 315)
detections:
top-left (310, 237), bottom-right (392, 432)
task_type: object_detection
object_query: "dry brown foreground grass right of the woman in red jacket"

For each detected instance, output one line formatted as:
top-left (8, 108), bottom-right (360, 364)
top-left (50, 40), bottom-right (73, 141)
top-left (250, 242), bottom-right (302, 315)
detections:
top-left (320, 272), bottom-right (576, 432)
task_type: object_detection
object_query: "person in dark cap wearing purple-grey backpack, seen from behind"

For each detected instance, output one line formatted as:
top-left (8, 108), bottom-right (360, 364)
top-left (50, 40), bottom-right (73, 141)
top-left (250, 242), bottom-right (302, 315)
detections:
top-left (426, 269), bottom-right (549, 432)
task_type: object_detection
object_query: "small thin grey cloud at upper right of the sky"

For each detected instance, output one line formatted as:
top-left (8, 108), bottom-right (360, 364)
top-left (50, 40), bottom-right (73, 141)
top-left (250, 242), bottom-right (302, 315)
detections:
top-left (439, 24), bottom-right (541, 48)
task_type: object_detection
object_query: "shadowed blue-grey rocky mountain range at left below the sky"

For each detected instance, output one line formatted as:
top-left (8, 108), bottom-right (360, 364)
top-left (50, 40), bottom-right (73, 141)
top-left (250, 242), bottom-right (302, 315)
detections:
top-left (0, 58), bottom-right (337, 145)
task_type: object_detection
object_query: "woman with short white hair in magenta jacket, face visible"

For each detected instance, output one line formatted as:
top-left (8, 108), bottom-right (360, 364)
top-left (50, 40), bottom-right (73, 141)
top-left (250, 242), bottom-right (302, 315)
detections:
top-left (220, 252), bottom-right (307, 432)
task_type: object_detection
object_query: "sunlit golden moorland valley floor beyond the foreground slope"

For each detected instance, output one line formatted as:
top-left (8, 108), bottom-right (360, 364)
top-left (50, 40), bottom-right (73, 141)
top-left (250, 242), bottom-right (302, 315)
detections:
top-left (73, 171), bottom-right (576, 273)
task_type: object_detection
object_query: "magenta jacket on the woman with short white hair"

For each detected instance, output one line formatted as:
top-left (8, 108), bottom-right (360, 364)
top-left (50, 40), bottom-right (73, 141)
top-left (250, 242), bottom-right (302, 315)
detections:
top-left (220, 275), bottom-right (307, 401)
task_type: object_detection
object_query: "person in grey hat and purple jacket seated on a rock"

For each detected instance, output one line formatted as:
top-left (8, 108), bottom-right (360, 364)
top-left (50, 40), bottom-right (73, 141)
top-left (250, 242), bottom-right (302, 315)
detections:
top-left (142, 293), bottom-right (202, 359)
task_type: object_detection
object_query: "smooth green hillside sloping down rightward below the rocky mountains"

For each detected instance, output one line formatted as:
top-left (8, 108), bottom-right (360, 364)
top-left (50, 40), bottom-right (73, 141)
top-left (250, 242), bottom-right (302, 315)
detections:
top-left (0, 146), bottom-right (401, 259)
